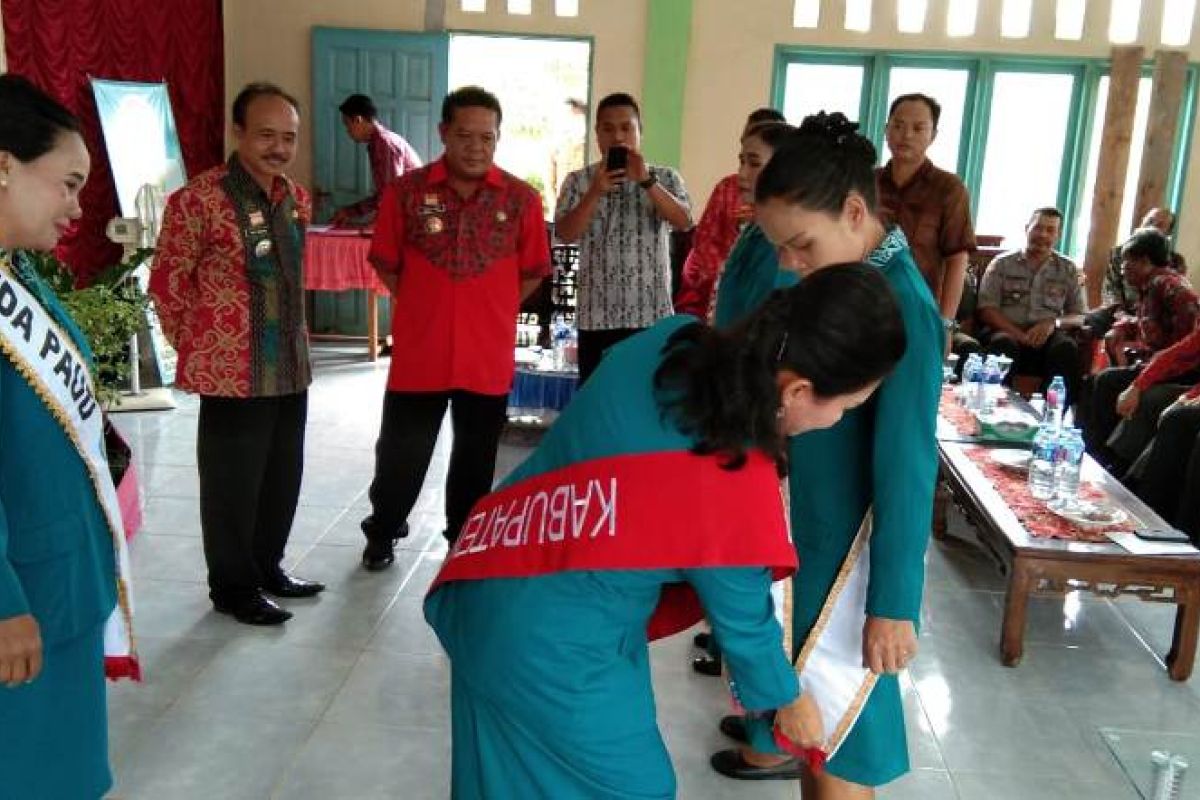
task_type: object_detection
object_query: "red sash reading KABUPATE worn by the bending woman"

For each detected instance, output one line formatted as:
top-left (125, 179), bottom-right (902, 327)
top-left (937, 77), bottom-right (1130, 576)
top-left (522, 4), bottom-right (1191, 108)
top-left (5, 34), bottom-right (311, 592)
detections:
top-left (430, 451), bottom-right (796, 639)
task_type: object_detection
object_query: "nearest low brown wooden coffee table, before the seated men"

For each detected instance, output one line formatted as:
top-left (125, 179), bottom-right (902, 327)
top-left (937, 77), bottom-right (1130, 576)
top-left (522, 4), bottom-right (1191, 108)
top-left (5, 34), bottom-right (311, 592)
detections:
top-left (934, 438), bottom-right (1200, 680)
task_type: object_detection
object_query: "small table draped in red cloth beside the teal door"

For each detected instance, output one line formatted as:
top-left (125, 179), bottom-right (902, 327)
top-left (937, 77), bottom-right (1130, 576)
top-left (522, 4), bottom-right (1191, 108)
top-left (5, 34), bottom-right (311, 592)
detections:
top-left (304, 227), bottom-right (388, 361)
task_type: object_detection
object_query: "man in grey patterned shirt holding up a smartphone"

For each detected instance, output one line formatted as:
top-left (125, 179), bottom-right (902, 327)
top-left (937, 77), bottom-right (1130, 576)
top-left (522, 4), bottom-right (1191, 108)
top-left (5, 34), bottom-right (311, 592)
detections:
top-left (554, 94), bottom-right (691, 383)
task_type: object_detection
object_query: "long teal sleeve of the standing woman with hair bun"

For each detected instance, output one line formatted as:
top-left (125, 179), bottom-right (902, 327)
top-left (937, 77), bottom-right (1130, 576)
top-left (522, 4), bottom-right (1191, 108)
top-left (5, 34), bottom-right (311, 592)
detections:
top-left (866, 269), bottom-right (944, 622)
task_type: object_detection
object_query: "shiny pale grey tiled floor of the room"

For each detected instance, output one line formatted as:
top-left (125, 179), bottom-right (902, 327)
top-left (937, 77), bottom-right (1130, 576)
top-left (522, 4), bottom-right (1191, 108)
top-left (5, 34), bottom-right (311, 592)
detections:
top-left (109, 350), bottom-right (1200, 800)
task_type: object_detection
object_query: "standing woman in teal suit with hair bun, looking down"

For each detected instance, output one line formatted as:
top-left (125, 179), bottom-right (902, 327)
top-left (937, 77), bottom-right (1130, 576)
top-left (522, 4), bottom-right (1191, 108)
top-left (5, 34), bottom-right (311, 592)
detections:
top-left (713, 114), bottom-right (944, 800)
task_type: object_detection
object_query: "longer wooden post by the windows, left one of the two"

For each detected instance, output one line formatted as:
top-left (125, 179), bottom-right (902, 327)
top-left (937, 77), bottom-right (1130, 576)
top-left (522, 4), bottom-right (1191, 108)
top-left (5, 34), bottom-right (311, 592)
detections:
top-left (1084, 47), bottom-right (1145, 308)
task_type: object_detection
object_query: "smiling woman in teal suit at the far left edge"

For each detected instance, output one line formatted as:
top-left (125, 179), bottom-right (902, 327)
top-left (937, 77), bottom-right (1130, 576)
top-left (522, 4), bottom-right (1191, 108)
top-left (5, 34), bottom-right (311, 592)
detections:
top-left (0, 74), bottom-right (116, 800)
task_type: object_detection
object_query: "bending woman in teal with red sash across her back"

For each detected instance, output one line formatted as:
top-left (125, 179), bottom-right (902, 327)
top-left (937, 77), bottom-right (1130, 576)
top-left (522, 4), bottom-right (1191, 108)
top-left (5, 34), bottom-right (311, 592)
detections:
top-left (425, 265), bottom-right (904, 800)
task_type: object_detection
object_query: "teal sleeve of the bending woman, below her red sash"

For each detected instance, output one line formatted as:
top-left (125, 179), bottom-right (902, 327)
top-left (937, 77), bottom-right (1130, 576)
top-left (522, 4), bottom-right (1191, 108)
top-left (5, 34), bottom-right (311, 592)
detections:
top-left (684, 567), bottom-right (800, 711)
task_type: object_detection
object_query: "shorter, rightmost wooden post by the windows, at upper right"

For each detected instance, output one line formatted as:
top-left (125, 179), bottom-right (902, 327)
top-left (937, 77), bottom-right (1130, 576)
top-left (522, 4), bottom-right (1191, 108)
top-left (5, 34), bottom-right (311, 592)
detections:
top-left (1133, 50), bottom-right (1188, 222)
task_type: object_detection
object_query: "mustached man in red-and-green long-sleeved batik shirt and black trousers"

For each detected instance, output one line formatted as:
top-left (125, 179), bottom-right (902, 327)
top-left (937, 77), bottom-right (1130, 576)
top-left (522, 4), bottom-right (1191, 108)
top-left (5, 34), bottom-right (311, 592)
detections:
top-left (150, 84), bottom-right (324, 625)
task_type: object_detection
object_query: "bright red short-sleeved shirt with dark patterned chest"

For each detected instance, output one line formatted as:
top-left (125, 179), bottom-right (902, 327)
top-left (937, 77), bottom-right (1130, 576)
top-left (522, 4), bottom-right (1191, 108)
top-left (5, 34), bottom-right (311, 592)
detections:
top-left (371, 160), bottom-right (551, 395)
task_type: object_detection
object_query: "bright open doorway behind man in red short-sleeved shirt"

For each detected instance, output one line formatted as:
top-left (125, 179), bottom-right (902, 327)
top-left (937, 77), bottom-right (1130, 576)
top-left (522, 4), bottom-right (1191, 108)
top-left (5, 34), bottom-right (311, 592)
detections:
top-left (449, 34), bottom-right (592, 218)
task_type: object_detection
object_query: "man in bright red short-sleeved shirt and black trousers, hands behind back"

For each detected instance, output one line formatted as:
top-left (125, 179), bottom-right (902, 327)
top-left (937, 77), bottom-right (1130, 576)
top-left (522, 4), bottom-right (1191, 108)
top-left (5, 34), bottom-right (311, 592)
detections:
top-left (362, 86), bottom-right (550, 571)
